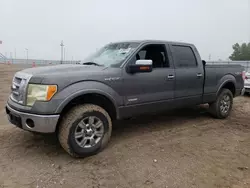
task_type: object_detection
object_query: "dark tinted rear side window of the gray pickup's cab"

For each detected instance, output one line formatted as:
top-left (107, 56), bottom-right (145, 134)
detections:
top-left (172, 45), bottom-right (197, 67)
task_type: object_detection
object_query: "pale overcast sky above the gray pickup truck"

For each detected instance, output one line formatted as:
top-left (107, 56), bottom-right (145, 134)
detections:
top-left (0, 0), bottom-right (250, 60)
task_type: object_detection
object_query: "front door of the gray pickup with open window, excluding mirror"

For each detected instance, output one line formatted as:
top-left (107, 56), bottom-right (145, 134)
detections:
top-left (120, 44), bottom-right (175, 115)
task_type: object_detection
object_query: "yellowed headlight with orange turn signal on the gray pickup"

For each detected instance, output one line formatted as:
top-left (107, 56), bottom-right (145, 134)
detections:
top-left (26, 84), bottom-right (57, 106)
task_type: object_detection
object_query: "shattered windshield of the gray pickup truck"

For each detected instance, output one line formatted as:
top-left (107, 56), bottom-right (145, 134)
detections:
top-left (83, 42), bottom-right (139, 67)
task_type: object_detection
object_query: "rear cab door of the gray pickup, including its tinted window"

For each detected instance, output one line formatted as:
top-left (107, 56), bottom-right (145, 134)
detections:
top-left (170, 44), bottom-right (204, 106)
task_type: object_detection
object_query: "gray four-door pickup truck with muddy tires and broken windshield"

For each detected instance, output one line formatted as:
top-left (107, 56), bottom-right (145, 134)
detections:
top-left (6, 40), bottom-right (244, 157)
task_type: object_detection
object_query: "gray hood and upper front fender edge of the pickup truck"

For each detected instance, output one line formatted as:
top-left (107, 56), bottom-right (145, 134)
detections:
top-left (21, 64), bottom-right (121, 90)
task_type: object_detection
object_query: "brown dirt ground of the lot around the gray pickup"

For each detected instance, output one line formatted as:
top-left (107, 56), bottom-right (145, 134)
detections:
top-left (0, 65), bottom-right (250, 188)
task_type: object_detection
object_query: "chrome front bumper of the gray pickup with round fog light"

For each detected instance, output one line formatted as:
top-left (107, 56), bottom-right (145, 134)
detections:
top-left (6, 105), bottom-right (60, 133)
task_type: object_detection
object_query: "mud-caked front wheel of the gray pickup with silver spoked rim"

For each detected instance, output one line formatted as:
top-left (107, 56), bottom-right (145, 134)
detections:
top-left (58, 104), bottom-right (112, 157)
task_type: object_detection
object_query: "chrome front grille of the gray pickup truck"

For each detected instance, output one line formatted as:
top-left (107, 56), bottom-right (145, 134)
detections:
top-left (11, 72), bottom-right (31, 104)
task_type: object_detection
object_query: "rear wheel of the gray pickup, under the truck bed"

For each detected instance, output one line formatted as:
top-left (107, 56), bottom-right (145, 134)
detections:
top-left (209, 89), bottom-right (233, 119)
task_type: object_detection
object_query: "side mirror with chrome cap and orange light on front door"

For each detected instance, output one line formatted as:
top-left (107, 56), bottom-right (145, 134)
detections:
top-left (128, 59), bottom-right (153, 74)
